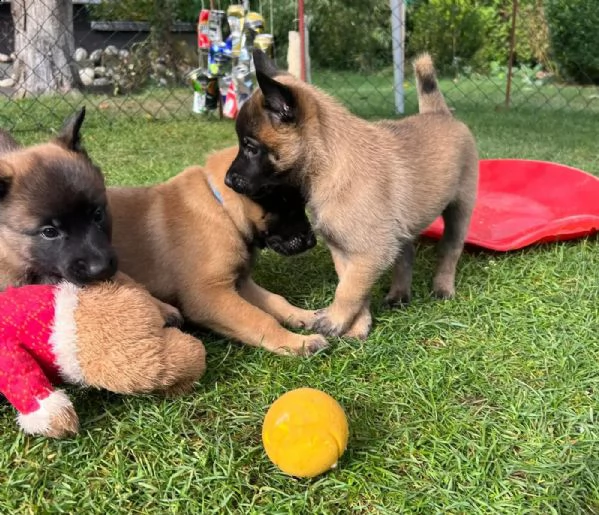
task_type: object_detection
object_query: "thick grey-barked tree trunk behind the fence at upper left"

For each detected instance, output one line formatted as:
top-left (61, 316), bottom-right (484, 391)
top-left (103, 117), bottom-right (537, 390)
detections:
top-left (11, 0), bottom-right (81, 97)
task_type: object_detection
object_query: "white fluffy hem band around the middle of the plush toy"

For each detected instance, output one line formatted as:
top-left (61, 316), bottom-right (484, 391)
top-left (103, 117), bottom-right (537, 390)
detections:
top-left (50, 282), bottom-right (84, 384)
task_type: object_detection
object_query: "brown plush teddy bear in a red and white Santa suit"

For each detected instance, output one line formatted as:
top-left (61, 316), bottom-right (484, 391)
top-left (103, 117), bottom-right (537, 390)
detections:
top-left (0, 282), bottom-right (206, 438)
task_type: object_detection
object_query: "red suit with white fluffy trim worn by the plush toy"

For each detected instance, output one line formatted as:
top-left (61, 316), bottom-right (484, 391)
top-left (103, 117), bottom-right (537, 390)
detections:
top-left (0, 283), bottom-right (83, 433)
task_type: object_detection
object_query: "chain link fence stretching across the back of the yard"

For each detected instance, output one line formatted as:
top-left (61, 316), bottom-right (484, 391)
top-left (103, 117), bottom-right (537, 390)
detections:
top-left (0, 0), bottom-right (599, 131)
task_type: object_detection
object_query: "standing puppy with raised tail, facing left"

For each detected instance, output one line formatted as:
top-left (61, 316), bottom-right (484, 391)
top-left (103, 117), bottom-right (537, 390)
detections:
top-left (225, 50), bottom-right (478, 338)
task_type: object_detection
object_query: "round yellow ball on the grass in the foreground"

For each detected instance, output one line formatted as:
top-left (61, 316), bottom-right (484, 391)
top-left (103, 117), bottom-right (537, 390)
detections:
top-left (262, 388), bottom-right (349, 477)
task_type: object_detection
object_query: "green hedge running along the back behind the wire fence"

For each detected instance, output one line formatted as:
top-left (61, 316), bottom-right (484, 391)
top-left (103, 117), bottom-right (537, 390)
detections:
top-left (85, 0), bottom-right (599, 83)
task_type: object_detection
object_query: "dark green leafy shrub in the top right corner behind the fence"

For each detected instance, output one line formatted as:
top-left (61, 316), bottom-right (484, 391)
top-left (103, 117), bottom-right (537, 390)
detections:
top-left (545, 0), bottom-right (599, 84)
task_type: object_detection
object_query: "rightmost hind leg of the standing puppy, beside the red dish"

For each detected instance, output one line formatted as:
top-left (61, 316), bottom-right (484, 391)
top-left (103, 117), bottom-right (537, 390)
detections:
top-left (433, 199), bottom-right (474, 299)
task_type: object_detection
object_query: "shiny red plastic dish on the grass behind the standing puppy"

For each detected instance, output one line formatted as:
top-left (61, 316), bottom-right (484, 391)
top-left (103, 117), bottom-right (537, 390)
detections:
top-left (423, 159), bottom-right (599, 251)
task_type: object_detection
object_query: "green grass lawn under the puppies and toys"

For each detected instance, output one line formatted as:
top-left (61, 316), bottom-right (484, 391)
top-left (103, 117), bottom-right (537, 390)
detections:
top-left (0, 83), bottom-right (599, 515)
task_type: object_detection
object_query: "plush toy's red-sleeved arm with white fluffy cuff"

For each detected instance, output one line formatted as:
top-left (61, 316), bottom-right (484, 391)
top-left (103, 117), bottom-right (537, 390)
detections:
top-left (0, 340), bottom-right (72, 434)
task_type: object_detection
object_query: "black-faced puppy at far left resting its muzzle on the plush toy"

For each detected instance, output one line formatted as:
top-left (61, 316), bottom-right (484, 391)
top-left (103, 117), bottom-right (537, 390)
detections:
top-left (0, 108), bottom-right (181, 325)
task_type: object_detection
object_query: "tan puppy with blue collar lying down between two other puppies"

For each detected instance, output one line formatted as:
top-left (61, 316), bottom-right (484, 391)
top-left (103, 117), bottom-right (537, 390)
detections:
top-left (108, 147), bottom-right (327, 354)
